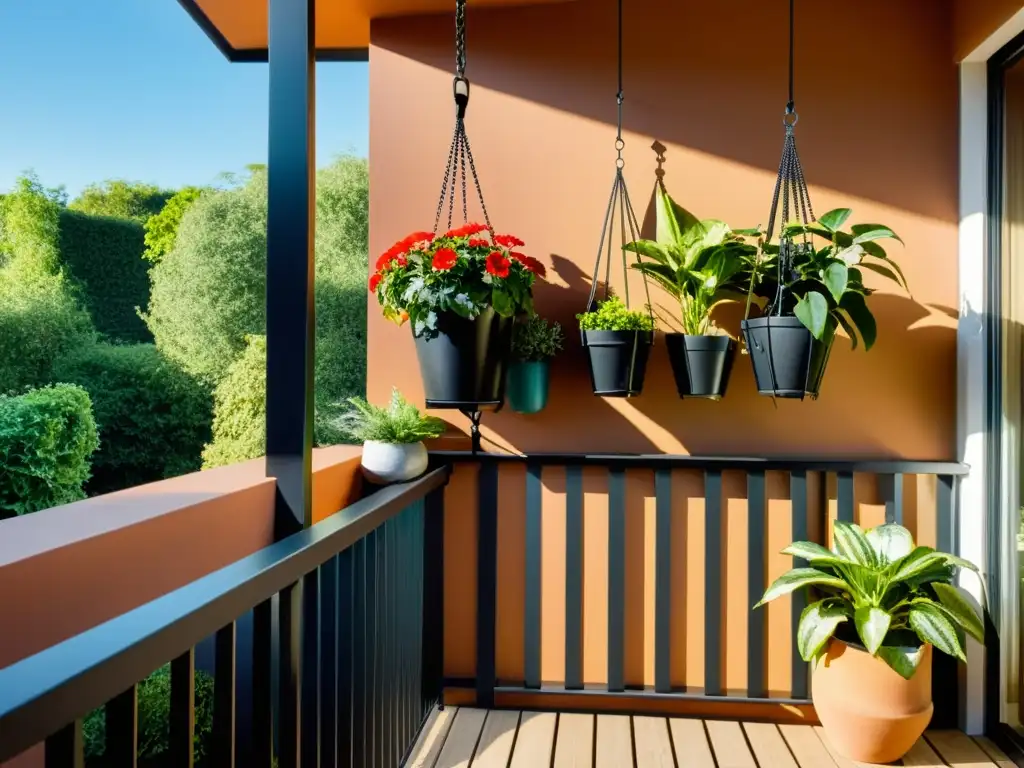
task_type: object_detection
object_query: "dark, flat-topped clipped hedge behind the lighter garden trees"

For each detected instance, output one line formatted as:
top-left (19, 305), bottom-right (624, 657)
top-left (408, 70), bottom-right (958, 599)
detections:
top-left (60, 210), bottom-right (153, 342)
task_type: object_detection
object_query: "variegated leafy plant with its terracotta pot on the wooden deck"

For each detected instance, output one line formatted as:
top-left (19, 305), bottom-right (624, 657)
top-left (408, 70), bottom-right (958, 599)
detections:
top-left (755, 521), bottom-right (984, 763)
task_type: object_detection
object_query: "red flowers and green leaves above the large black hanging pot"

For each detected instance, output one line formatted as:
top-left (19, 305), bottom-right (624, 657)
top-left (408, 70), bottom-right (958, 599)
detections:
top-left (370, 224), bottom-right (545, 336)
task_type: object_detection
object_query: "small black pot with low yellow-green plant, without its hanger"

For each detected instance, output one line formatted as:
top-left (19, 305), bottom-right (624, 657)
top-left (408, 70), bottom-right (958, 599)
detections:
top-left (577, 296), bottom-right (654, 397)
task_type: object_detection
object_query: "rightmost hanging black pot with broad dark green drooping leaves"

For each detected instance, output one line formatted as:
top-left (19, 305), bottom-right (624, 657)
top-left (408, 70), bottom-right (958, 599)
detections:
top-left (742, 208), bottom-right (906, 399)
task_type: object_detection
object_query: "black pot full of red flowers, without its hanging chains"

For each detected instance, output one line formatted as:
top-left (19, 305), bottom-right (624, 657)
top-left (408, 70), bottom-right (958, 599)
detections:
top-left (370, 224), bottom-right (544, 411)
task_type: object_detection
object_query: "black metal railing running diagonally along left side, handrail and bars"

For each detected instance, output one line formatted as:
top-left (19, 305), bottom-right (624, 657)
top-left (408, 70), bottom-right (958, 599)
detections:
top-left (0, 468), bottom-right (449, 768)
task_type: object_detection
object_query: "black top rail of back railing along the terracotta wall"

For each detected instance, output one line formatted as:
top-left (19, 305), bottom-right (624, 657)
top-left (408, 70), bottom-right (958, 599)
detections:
top-left (430, 451), bottom-right (971, 476)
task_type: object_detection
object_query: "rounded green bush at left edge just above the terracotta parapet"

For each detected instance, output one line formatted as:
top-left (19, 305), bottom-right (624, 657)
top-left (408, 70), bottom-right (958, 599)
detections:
top-left (0, 384), bottom-right (99, 518)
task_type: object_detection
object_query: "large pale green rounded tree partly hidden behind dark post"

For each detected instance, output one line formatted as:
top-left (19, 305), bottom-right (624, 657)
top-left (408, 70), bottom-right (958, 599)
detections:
top-left (145, 158), bottom-right (369, 443)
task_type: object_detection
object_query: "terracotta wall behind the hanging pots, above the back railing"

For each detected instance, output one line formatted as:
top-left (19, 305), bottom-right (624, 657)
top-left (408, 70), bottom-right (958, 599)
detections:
top-left (369, 0), bottom-right (957, 459)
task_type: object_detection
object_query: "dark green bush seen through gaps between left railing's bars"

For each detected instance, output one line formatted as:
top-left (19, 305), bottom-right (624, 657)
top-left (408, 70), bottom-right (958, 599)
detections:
top-left (82, 665), bottom-right (213, 768)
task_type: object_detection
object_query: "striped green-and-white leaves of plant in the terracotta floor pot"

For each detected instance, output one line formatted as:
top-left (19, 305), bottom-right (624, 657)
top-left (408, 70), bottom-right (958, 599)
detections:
top-left (755, 521), bottom-right (985, 679)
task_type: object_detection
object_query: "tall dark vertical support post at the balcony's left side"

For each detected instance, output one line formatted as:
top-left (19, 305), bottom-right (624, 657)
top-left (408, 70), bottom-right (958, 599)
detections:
top-left (266, 0), bottom-right (316, 538)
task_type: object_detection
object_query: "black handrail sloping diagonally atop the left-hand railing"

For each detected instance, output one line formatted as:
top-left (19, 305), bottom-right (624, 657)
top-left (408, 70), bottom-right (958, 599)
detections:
top-left (0, 467), bottom-right (450, 763)
